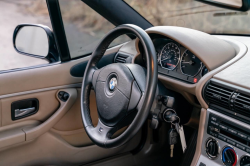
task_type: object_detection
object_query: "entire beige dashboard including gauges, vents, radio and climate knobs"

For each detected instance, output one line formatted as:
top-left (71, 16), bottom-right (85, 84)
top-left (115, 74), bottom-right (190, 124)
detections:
top-left (118, 26), bottom-right (250, 166)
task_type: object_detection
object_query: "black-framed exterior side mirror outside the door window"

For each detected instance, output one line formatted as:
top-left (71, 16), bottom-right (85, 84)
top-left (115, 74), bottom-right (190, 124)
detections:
top-left (13, 24), bottom-right (59, 62)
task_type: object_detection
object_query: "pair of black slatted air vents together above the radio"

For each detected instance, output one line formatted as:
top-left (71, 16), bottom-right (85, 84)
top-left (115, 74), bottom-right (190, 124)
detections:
top-left (203, 79), bottom-right (250, 124)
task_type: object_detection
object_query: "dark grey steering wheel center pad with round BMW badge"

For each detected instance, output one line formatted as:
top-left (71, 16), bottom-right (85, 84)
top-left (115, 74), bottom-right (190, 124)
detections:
top-left (93, 63), bottom-right (134, 126)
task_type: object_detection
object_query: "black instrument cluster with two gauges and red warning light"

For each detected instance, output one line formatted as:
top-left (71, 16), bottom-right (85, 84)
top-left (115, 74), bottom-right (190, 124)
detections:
top-left (153, 38), bottom-right (208, 83)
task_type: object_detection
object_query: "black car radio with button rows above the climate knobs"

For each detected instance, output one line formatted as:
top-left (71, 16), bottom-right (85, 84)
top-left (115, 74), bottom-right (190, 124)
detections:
top-left (207, 113), bottom-right (250, 153)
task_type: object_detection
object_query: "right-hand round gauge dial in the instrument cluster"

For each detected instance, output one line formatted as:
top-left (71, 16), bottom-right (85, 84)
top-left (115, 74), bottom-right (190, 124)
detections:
top-left (181, 50), bottom-right (202, 77)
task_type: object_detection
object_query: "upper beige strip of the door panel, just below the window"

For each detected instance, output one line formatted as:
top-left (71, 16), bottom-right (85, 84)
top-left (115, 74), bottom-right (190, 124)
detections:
top-left (0, 45), bottom-right (121, 98)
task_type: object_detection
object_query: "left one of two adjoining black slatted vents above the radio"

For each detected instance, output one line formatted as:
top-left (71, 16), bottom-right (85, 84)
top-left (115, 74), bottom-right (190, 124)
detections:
top-left (204, 81), bottom-right (234, 109)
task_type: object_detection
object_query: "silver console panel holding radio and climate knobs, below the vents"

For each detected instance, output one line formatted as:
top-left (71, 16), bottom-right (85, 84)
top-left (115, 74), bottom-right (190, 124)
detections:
top-left (197, 109), bottom-right (250, 166)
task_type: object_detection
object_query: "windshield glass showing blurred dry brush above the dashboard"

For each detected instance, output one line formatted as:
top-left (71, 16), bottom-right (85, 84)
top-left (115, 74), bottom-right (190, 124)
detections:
top-left (125, 0), bottom-right (250, 35)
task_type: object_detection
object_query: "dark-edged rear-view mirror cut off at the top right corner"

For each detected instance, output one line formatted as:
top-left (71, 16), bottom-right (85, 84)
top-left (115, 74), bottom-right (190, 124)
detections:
top-left (196, 0), bottom-right (250, 12)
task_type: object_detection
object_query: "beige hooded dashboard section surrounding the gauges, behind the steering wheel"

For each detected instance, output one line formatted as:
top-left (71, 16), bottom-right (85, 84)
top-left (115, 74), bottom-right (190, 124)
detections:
top-left (120, 26), bottom-right (237, 98)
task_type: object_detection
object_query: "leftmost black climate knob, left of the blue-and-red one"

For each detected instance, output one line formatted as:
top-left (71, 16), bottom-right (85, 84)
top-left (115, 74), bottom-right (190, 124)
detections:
top-left (206, 138), bottom-right (219, 159)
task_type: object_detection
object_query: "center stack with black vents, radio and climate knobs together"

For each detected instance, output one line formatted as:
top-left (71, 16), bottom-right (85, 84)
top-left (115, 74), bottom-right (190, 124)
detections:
top-left (197, 80), bottom-right (250, 166)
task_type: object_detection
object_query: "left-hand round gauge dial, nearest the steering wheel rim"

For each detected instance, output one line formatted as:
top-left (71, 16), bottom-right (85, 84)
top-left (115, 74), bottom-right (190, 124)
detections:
top-left (160, 43), bottom-right (181, 70)
